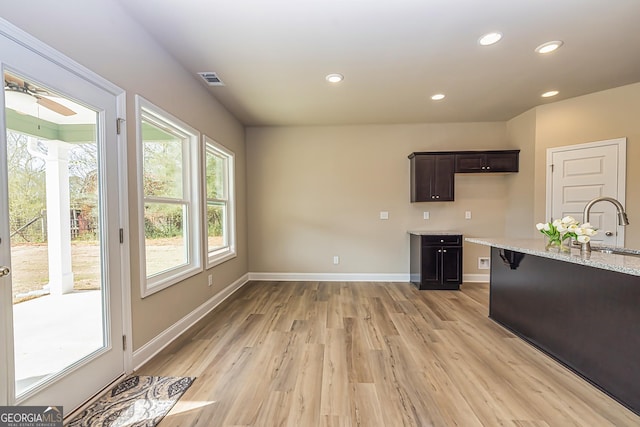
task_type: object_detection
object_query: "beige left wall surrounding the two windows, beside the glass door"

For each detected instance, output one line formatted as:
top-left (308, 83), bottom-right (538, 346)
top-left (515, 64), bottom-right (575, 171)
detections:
top-left (2, 0), bottom-right (248, 350)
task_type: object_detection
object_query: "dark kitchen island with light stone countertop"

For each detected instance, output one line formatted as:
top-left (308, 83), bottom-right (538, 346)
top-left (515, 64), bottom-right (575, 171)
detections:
top-left (465, 238), bottom-right (640, 414)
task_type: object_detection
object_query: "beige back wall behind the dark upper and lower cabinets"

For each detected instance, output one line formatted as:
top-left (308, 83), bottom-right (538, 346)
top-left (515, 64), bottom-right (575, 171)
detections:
top-left (247, 122), bottom-right (517, 274)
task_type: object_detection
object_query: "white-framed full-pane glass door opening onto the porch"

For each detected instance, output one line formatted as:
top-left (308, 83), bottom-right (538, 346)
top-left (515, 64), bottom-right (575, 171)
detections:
top-left (0, 25), bottom-right (124, 413)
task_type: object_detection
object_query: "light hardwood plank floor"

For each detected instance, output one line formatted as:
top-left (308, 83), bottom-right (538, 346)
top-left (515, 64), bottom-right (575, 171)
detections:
top-left (139, 282), bottom-right (640, 427)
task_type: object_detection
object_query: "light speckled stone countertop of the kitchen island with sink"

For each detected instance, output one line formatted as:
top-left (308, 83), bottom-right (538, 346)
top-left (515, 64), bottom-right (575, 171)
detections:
top-left (464, 237), bottom-right (640, 276)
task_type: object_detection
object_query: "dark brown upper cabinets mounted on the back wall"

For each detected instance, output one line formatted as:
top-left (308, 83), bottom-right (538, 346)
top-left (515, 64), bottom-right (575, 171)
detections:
top-left (409, 150), bottom-right (520, 202)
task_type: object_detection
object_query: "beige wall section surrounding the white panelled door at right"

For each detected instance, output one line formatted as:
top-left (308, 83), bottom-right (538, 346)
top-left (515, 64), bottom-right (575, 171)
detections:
top-left (507, 83), bottom-right (640, 248)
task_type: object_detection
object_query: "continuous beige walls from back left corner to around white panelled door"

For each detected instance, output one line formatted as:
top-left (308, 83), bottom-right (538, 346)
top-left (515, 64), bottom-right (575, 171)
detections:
top-left (247, 83), bottom-right (640, 280)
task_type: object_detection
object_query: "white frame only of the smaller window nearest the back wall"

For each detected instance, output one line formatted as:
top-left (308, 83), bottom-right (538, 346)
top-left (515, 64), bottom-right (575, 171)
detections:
top-left (202, 135), bottom-right (237, 269)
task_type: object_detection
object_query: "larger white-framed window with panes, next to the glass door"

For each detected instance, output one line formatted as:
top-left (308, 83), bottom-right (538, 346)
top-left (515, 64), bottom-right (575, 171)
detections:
top-left (136, 96), bottom-right (202, 297)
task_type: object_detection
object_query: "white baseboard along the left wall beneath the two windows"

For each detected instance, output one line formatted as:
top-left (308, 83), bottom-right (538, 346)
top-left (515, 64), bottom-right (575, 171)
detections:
top-left (133, 274), bottom-right (249, 370)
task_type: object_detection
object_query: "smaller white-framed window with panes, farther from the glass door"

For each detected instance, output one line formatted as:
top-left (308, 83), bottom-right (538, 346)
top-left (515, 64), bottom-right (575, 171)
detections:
top-left (204, 136), bottom-right (236, 267)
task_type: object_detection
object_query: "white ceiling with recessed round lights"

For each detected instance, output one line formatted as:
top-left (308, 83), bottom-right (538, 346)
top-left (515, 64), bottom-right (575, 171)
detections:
top-left (120, 0), bottom-right (640, 125)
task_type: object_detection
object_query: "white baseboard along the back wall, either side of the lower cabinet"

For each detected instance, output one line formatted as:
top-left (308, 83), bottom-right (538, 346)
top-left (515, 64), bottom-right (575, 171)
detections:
top-left (249, 273), bottom-right (489, 282)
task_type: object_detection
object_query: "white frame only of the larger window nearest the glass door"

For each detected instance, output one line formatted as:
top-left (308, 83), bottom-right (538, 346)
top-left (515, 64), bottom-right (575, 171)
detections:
top-left (135, 95), bottom-right (203, 298)
